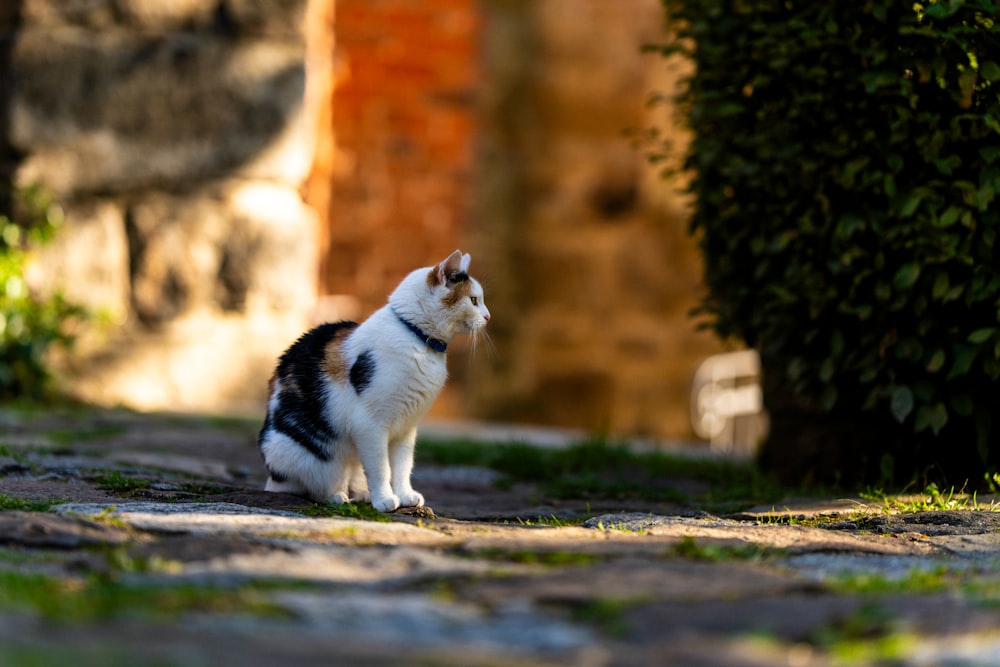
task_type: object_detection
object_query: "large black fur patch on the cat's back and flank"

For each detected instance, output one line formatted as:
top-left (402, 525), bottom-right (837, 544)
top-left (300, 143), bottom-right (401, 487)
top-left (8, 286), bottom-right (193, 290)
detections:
top-left (258, 322), bottom-right (358, 462)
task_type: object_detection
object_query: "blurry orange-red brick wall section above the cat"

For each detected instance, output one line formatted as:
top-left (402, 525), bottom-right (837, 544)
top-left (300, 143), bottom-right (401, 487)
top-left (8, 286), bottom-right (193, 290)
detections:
top-left (321, 0), bottom-right (479, 316)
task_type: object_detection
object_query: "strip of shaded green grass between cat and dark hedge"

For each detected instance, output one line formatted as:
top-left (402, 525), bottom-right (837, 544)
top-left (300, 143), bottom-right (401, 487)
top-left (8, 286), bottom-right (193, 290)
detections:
top-left (417, 438), bottom-right (788, 509)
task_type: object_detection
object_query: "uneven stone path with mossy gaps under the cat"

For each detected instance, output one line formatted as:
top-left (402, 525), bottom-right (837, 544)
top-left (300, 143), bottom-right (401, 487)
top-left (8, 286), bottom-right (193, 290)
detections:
top-left (0, 411), bottom-right (1000, 666)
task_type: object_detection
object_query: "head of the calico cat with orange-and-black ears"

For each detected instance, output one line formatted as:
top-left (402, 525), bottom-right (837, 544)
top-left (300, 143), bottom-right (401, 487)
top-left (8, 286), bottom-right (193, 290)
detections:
top-left (389, 250), bottom-right (490, 340)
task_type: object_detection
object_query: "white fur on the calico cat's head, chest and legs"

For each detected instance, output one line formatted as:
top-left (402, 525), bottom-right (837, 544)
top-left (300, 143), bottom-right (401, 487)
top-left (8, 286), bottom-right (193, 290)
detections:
top-left (261, 250), bottom-right (490, 512)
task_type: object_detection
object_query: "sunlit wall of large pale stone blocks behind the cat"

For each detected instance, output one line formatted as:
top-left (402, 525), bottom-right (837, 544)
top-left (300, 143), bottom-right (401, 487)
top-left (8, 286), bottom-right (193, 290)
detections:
top-left (8, 0), bottom-right (316, 411)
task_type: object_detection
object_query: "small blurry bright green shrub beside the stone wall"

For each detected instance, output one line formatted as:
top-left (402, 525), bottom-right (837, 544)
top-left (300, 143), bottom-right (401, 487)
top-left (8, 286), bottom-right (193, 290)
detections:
top-left (0, 188), bottom-right (85, 400)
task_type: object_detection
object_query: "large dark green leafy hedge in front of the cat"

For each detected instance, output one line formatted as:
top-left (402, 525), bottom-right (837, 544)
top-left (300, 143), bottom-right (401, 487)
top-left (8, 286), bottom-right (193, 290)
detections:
top-left (663, 0), bottom-right (1000, 477)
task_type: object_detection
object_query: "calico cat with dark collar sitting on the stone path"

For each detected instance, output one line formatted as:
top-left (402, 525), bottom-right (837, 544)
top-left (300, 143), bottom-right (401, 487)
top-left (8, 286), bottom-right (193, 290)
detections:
top-left (258, 250), bottom-right (490, 512)
